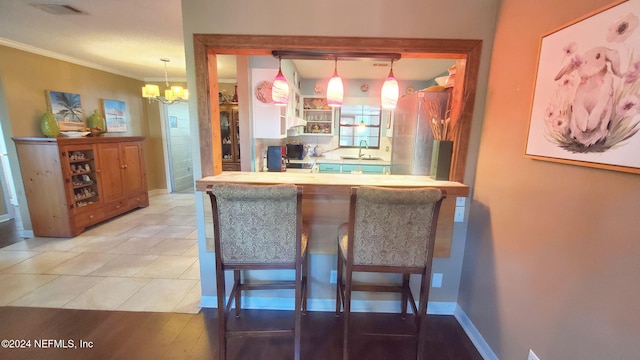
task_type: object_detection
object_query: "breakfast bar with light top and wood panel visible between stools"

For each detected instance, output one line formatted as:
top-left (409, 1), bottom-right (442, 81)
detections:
top-left (196, 172), bottom-right (469, 257)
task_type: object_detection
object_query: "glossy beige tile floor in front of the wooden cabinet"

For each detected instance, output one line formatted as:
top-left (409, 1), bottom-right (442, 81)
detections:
top-left (0, 193), bottom-right (200, 313)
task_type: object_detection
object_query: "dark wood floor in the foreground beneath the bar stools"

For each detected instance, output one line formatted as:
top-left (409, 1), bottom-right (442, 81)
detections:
top-left (0, 307), bottom-right (482, 360)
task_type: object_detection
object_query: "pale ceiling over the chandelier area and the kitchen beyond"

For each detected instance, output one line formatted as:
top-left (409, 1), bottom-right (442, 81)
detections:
top-left (0, 0), bottom-right (454, 81)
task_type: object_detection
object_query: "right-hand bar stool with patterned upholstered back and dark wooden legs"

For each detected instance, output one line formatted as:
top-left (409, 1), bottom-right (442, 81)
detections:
top-left (336, 186), bottom-right (446, 360)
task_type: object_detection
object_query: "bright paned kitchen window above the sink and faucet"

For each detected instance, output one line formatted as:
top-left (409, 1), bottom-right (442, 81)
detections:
top-left (339, 105), bottom-right (381, 149)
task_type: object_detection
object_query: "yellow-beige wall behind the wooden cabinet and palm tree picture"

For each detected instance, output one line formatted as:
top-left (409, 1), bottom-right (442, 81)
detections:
top-left (0, 46), bottom-right (166, 229)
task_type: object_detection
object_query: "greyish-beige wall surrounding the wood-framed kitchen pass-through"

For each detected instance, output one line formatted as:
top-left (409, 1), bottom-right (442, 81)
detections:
top-left (182, 0), bottom-right (498, 310)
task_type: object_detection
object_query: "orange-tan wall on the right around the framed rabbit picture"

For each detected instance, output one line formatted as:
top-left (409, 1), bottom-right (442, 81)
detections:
top-left (459, 0), bottom-right (640, 360)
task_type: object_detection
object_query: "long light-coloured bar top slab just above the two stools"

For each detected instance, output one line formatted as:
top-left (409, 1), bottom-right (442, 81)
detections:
top-left (196, 172), bottom-right (469, 197)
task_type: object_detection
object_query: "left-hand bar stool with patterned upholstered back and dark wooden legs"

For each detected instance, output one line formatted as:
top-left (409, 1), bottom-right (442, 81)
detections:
top-left (208, 184), bottom-right (309, 360)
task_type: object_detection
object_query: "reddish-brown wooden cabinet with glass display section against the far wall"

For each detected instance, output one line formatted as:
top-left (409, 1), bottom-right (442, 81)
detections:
top-left (13, 136), bottom-right (149, 237)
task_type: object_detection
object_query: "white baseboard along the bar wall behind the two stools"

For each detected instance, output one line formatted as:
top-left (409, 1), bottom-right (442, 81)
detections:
top-left (200, 296), bottom-right (457, 315)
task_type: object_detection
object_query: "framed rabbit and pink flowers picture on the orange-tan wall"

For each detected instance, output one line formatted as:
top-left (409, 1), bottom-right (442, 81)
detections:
top-left (525, 0), bottom-right (640, 174)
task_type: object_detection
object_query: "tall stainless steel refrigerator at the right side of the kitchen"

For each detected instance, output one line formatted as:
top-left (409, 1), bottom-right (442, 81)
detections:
top-left (391, 91), bottom-right (450, 175)
